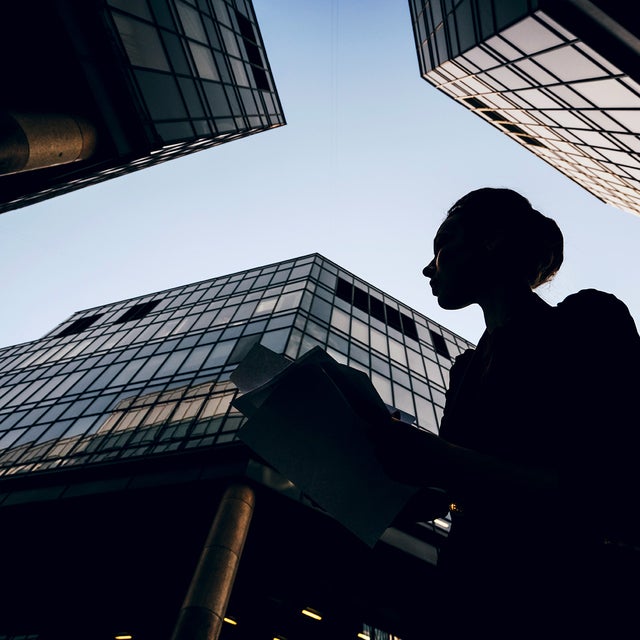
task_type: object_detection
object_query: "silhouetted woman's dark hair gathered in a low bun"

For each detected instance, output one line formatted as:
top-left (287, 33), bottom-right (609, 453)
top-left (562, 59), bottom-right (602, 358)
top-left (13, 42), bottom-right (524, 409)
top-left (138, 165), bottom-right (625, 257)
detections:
top-left (447, 187), bottom-right (564, 289)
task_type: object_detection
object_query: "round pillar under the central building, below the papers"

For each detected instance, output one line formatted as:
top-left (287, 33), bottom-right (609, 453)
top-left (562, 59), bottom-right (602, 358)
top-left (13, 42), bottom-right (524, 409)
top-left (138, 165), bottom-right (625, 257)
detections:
top-left (172, 484), bottom-right (255, 640)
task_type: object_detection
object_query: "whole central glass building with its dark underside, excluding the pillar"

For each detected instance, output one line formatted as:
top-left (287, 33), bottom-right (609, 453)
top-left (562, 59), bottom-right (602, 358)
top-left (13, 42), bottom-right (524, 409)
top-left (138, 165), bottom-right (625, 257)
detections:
top-left (0, 254), bottom-right (470, 640)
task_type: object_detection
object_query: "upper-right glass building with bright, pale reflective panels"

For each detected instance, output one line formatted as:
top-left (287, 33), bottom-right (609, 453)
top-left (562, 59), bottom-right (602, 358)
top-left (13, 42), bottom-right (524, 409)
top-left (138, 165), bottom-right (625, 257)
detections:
top-left (409, 0), bottom-right (640, 213)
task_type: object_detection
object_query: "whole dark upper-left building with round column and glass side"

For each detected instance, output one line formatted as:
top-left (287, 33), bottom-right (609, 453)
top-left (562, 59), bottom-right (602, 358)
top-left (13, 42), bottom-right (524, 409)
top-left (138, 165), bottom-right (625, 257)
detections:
top-left (0, 0), bottom-right (285, 213)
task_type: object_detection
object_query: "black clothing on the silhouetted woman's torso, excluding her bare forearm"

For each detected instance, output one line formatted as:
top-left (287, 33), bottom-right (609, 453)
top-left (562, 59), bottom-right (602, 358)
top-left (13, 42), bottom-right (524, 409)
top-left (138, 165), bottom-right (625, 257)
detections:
top-left (440, 290), bottom-right (640, 636)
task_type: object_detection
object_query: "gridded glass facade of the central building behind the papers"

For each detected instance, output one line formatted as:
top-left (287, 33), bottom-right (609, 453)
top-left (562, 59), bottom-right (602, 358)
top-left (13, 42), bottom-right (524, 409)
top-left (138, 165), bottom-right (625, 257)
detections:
top-left (0, 254), bottom-right (470, 482)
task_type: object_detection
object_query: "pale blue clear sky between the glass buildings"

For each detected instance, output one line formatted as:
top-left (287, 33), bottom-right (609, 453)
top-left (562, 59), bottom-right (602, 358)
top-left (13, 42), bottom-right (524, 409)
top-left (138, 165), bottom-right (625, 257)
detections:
top-left (0, 0), bottom-right (640, 347)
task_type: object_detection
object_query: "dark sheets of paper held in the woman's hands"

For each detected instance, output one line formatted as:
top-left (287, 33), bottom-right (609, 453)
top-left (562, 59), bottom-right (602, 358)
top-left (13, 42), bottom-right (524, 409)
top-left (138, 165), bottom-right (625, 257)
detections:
top-left (231, 345), bottom-right (417, 547)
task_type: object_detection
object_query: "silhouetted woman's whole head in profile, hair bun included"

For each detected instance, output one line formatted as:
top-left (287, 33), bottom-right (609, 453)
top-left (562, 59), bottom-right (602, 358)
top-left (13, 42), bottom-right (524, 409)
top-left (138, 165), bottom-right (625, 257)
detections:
top-left (423, 187), bottom-right (563, 309)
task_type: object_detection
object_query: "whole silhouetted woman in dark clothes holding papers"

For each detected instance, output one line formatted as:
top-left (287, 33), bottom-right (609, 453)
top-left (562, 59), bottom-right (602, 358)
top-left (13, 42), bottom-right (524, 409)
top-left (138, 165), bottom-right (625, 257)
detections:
top-left (373, 188), bottom-right (640, 638)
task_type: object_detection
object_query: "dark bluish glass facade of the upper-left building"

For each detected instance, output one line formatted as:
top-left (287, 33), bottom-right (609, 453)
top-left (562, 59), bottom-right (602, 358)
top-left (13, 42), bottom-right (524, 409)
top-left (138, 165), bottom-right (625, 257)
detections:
top-left (107, 0), bottom-right (284, 142)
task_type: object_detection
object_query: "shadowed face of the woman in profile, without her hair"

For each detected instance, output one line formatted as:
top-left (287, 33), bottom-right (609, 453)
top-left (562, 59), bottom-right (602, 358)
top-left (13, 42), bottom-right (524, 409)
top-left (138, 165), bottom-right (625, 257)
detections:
top-left (422, 215), bottom-right (487, 309)
